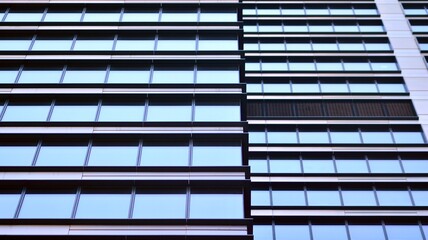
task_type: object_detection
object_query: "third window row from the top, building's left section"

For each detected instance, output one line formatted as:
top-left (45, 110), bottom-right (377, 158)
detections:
top-left (0, 64), bottom-right (239, 84)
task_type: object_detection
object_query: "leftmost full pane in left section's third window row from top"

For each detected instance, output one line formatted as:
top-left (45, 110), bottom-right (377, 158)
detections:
top-left (18, 70), bottom-right (62, 83)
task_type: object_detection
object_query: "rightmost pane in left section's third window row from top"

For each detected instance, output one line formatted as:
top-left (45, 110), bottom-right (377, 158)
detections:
top-left (196, 70), bottom-right (239, 83)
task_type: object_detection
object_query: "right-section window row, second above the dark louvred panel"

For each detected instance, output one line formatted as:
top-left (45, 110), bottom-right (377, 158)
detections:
top-left (245, 58), bottom-right (399, 72)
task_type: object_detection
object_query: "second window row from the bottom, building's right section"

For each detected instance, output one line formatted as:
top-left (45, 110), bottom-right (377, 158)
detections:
top-left (251, 187), bottom-right (428, 207)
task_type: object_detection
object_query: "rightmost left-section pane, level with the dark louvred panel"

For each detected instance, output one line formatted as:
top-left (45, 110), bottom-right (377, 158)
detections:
top-left (195, 105), bottom-right (241, 122)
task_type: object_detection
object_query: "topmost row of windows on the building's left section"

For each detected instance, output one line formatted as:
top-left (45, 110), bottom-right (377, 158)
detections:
top-left (0, 7), bottom-right (237, 23)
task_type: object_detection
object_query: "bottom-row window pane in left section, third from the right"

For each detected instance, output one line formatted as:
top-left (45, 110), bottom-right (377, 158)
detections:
top-left (76, 193), bottom-right (131, 218)
